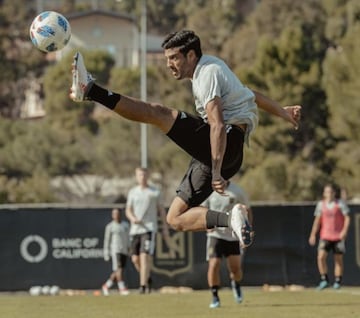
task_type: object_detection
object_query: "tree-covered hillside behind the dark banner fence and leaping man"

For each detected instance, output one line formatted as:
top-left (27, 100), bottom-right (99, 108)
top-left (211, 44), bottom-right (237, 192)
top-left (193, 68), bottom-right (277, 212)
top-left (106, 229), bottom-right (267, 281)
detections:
top-left (0, 0), bottom-right (360, 203)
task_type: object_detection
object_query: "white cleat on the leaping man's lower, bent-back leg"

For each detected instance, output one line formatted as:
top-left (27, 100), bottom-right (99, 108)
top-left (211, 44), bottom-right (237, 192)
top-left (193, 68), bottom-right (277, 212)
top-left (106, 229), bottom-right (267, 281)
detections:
top-left (230, 204), bottom-right (254, 247)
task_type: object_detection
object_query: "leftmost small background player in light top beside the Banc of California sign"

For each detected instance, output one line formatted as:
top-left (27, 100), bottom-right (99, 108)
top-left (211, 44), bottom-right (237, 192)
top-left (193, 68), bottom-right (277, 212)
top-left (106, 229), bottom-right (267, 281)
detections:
top-left (102, 209), bottom-right (129, 296)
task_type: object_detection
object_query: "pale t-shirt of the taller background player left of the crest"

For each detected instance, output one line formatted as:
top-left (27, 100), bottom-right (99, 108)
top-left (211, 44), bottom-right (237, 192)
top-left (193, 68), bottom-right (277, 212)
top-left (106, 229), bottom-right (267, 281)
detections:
top-left (126, 186), bottom-right (161, 235)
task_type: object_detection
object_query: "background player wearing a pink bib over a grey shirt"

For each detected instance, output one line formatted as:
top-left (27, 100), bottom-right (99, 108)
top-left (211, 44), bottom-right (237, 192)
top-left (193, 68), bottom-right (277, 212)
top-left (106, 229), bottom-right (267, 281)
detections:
top-left (309, 184), bottom-right (350, 290)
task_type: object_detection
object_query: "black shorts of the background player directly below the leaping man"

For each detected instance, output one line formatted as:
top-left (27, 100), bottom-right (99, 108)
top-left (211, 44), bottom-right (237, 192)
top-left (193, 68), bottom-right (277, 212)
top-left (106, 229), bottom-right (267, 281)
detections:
top-left (206, 236), bottom-right (242, 260)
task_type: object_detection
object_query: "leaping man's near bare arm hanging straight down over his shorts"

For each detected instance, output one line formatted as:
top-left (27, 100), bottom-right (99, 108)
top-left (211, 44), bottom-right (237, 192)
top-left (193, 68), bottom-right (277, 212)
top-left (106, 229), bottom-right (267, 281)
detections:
top-left (205, 97), bottom-right (226, 194)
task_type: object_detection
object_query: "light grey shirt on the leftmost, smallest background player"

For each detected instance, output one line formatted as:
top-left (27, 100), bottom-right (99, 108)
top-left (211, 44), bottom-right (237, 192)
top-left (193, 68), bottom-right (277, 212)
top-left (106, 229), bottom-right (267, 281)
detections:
top-left (104, 221), bottom-right (129, 256)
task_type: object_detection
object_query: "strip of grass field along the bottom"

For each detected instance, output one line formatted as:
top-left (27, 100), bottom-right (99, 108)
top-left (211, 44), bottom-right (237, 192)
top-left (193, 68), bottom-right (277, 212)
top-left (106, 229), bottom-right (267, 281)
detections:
top-left (0, 287), bottom-right (360, 318)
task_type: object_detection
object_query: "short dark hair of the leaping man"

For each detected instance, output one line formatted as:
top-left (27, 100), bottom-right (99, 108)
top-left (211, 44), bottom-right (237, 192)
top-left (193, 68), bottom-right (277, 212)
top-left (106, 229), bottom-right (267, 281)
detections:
top-left (161, 30), bottom-right (202, 58)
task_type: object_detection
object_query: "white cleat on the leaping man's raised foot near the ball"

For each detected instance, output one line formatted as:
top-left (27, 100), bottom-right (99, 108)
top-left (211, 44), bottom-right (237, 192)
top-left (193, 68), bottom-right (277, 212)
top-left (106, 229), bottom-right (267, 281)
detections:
top-left (70, 52), bottom-right (95, 102)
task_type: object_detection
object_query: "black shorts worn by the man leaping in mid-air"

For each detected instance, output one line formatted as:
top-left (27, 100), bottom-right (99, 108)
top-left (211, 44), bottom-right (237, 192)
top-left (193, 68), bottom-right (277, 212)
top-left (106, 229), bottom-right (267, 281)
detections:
top-left (167, 112), bottom-right (244, 207)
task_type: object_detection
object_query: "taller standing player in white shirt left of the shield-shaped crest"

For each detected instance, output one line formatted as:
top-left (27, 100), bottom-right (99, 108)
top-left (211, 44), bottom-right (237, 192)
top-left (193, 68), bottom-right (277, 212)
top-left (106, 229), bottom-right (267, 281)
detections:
top-left (126, 168), bottom-right (169, 294)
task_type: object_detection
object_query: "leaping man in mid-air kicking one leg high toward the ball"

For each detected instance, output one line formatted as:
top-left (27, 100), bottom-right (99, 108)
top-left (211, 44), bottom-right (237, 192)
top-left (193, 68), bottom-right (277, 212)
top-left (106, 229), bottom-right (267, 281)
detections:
top-left (70, 30), bottom-right (301, 245)
